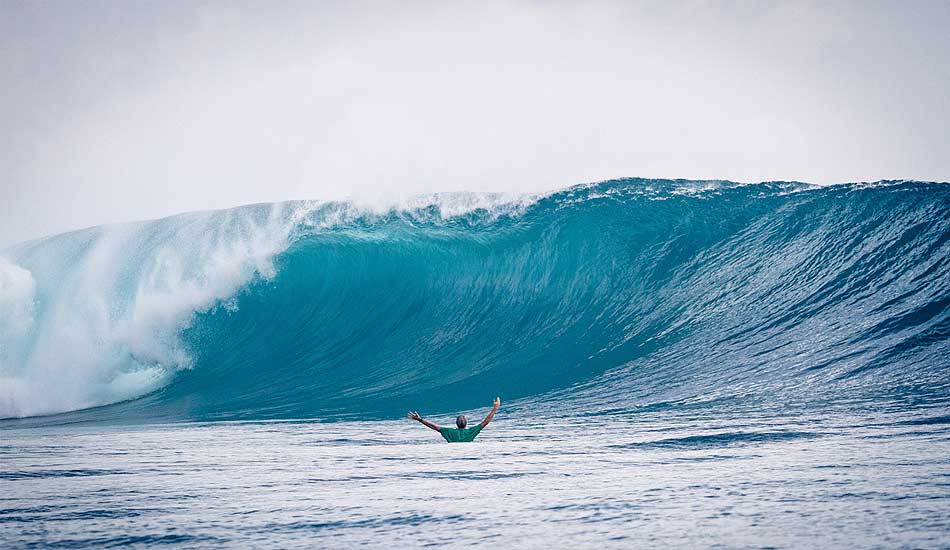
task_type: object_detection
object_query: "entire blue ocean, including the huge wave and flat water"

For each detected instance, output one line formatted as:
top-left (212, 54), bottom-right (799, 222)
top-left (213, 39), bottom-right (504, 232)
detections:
top-left (0, 179), bottom-right (950, 548)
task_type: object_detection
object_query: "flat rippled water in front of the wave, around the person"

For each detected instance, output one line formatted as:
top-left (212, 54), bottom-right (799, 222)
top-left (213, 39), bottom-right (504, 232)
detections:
top-left (0, 403), bottom-right (950, 548)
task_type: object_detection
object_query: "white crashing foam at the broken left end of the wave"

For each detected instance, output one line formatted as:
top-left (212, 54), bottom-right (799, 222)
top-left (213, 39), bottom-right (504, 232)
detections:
top-left (0, 204), bottom-right (312, 417)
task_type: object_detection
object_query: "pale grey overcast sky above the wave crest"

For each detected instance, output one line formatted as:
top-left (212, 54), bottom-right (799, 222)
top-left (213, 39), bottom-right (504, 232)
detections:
top-left (0, 0), bottom-right (950, 246)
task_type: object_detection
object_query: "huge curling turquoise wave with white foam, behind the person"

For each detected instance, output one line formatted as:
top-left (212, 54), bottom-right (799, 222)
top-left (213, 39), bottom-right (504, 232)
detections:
top-left (0, 179), bottom-right (950, 420)
